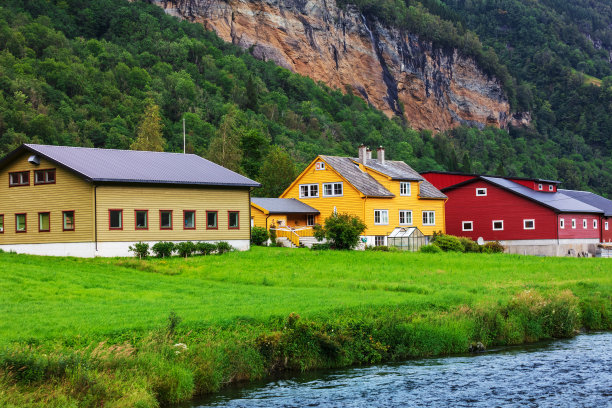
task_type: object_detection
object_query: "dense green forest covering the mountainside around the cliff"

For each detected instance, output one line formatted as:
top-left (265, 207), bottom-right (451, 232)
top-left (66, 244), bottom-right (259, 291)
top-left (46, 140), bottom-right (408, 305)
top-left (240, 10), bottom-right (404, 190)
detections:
top-left (0, 0), bottom-right (612, 195)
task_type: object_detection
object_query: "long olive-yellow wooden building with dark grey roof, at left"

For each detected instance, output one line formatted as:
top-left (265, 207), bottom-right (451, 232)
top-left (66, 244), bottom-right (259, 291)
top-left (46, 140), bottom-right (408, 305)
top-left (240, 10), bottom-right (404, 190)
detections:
top-left (0, 144), bottom-right (259, 257)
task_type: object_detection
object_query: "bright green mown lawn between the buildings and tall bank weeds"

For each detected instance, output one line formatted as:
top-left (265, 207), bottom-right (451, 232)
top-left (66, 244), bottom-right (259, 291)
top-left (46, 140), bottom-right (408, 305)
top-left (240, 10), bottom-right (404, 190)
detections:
top-left (0, 248), bottom-right (612, 341)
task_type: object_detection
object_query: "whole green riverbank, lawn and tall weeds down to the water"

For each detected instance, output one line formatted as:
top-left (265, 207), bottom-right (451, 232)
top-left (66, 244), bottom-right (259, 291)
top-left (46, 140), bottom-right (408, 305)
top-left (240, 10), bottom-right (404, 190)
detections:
top-left (0, 248), bottom-right (612, 407)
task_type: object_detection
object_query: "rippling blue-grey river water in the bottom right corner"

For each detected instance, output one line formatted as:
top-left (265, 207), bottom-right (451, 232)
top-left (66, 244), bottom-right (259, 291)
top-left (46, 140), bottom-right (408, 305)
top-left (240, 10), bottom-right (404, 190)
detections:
top-left (191, 333), bottom-right (612, 408)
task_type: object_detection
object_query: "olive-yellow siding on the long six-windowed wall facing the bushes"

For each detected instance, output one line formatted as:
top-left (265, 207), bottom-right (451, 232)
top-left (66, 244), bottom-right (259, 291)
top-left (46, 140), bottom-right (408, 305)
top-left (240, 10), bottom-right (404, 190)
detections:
top-left (97, 186), bottom-right (251, 242)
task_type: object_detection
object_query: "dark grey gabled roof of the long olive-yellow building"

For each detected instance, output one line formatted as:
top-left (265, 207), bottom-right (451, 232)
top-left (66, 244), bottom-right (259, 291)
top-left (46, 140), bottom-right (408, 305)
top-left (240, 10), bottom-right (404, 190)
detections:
top-left (0, 144), bottom-right (261, 187)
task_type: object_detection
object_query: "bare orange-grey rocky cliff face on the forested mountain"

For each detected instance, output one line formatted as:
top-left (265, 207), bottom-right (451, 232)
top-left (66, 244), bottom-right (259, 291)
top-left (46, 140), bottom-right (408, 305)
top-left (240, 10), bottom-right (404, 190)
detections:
top-left (149, 0), bottom-right (509, 131)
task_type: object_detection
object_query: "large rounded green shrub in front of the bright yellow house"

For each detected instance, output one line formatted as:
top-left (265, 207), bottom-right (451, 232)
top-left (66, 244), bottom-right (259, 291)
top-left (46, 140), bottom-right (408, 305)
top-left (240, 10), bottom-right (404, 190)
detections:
top-left (314, 214), bottom-right (366, 249)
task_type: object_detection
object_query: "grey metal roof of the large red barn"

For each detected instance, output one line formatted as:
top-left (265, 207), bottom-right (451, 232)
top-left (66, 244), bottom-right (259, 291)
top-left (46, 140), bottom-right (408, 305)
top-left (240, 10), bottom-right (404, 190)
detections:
top-left (481, 176), bottom-right (603, 213)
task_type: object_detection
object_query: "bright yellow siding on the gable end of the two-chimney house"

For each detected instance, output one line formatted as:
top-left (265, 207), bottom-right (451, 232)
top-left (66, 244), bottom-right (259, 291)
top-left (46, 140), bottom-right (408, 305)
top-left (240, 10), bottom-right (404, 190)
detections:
top-left (280, 159), bottom-right (364, 224)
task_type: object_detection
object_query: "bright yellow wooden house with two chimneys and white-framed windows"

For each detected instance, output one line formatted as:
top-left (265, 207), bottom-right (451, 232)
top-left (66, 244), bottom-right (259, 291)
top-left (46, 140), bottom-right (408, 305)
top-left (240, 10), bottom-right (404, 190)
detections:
top-left (280, 146), bottom-right (447, 245)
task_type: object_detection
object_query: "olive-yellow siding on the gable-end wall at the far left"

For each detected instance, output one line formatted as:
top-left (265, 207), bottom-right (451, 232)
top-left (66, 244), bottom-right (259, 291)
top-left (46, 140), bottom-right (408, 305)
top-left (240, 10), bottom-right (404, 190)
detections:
top-left (0, 154), bottom-right (94, 244)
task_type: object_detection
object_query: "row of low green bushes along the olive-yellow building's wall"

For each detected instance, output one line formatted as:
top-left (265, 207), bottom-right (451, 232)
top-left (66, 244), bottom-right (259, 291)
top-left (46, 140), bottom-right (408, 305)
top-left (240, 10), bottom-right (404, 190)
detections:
top-left (129, 241), bottom-right (234, 259)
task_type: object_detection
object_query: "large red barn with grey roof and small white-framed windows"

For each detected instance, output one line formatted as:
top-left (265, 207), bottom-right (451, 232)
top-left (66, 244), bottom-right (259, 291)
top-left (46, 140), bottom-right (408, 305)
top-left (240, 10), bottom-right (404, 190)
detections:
top-left (423, 172), bottom-right (610, 255)
